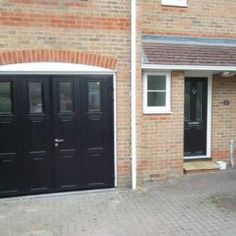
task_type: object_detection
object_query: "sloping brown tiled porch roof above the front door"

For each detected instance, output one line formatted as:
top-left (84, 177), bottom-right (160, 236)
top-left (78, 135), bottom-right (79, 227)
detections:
top-left (143, 42), bottom-right (236, 66)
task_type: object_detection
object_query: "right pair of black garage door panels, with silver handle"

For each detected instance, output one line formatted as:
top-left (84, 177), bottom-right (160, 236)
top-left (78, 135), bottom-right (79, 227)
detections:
top-left (53, 75), bottom-right (114, 190)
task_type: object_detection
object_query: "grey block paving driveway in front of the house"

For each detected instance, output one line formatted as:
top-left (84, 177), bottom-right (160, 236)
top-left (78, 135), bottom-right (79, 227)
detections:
top-left (0, 170), bottom-right (236, 236)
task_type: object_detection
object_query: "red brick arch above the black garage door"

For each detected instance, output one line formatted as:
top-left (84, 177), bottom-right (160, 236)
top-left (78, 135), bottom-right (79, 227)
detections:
top-left (0, 49), bottom-right (117, 70)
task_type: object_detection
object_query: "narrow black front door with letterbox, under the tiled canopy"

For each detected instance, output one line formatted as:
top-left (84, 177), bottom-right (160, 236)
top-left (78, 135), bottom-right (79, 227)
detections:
top-left (184, 78), bottom-right (207, 157)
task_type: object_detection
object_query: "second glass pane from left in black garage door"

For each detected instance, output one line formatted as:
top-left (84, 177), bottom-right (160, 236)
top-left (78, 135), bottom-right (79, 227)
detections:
top-left (29, 82), bottom-right (43, 113)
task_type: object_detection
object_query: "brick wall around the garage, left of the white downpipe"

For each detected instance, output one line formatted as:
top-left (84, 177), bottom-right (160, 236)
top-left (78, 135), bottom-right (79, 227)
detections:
top-left (0, 0), bottom-right (130, 186)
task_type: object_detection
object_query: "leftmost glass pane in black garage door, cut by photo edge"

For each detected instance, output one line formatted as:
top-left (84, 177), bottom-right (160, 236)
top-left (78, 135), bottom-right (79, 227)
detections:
top-left (0, 82), bottom-right (12, 113)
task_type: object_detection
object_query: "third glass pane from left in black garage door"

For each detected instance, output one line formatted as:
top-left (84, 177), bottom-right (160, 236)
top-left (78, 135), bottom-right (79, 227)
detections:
top-left (59, 82), bottom-right (73, 112)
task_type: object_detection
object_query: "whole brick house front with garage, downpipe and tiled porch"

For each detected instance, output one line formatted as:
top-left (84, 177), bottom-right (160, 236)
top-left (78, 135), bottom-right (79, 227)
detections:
top-left (0, 0), bottom-right (236, 196)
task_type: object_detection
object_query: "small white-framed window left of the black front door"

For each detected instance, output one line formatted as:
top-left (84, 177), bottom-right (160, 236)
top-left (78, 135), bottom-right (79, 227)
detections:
top-left (143, 73), bottom-right (171, 114)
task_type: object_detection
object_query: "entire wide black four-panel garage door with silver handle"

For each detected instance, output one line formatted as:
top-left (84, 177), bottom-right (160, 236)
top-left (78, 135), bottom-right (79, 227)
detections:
top-left (0, 75), bottom-right (114, 196)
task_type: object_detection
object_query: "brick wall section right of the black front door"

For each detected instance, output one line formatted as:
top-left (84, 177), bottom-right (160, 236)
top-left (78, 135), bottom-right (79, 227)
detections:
top-left (212, 76), bottom-right (236, 160)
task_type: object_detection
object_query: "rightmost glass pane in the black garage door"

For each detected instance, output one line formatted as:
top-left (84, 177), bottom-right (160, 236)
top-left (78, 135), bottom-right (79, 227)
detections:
top-left (88, 82), bottom-right (101, 111)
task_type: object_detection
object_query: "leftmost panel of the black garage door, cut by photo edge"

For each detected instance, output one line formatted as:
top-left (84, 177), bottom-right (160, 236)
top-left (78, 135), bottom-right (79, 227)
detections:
top-left (0, 76), bottom-right (23, 195)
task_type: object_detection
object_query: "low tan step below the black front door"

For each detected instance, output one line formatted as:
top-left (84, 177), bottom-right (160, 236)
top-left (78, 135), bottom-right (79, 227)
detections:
top-left (184, 161), bottom-right (219, 174)
